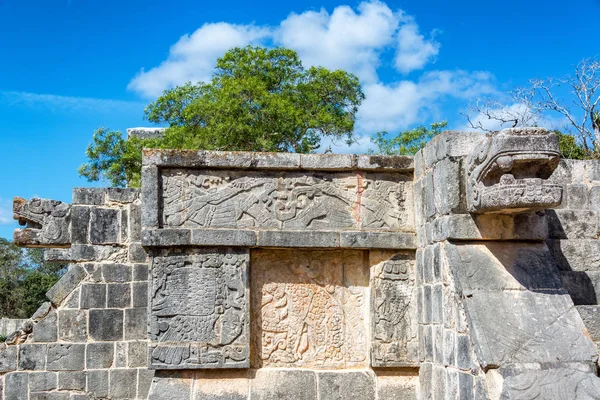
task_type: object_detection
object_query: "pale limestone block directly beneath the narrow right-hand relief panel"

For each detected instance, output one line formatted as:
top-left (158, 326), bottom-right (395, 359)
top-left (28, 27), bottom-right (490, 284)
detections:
top-left (376, 370), bottom-right (419, 400)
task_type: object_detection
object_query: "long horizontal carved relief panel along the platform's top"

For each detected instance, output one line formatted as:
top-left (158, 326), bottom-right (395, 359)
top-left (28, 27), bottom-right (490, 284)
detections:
top-left (161, 169), bottom-right (413, 230)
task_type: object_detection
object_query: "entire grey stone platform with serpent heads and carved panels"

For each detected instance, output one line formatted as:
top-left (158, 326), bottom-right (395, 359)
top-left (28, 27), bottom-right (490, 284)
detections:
top-left (0, 128), bottom-right (600, 400)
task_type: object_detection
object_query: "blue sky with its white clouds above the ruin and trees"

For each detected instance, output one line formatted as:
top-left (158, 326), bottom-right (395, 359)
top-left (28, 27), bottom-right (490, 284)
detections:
top-left (0, 0), bottom-right (600, 238)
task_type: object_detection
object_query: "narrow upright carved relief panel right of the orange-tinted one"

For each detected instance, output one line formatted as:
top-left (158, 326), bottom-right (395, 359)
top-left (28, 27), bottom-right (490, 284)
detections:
top-left (370, 250), bottom-right (419, 367)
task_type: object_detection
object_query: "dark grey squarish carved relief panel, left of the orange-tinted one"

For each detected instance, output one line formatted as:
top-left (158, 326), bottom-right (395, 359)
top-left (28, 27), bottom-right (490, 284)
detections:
top-left (149, 249), bottom-right (249, 369)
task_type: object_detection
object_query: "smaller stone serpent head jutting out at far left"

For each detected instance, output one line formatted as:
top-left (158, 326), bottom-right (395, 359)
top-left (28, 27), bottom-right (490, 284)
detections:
top-left (13, 197), bottom-right (71, 247)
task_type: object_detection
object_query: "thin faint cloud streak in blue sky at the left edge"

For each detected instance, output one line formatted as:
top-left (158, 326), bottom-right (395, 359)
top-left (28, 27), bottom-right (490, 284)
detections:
top-left (0, 91), bottom-right (144, 112)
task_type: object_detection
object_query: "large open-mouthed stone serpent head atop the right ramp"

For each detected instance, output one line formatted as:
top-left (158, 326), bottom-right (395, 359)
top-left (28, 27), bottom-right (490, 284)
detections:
top-left (467, 128), bottom-right (562, 213)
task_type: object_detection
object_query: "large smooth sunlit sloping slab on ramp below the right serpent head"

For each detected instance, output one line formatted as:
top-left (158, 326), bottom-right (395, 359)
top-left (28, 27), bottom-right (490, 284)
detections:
top-left (458, 291), bottom-right (597, 368)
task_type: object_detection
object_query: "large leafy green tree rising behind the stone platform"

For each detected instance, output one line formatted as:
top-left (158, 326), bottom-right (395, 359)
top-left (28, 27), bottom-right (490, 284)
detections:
top-left (79, 46), bottom-right (364, 186)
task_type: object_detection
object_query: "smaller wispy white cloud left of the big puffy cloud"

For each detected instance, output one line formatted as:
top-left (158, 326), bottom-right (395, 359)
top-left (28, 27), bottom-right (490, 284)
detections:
top-left (127, 22), bottom-right (270, 97)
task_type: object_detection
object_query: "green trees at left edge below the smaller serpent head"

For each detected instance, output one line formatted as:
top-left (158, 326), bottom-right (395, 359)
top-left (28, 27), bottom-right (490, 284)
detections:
top-left (0, 238), bottom-right (66, 318)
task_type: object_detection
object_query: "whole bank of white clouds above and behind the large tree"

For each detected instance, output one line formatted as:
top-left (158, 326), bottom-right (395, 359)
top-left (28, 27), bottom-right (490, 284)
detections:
top-left (124, 0), bottom-right (494, 138)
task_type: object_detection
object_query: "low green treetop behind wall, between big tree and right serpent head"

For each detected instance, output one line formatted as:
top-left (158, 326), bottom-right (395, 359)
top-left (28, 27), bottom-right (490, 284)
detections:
top-left (371, 121), bottom-right (448, 155)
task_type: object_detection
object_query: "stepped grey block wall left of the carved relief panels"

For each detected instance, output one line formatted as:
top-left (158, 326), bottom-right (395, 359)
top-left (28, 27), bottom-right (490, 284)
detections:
top-left (0, 189), bottom-right (154, 400)
